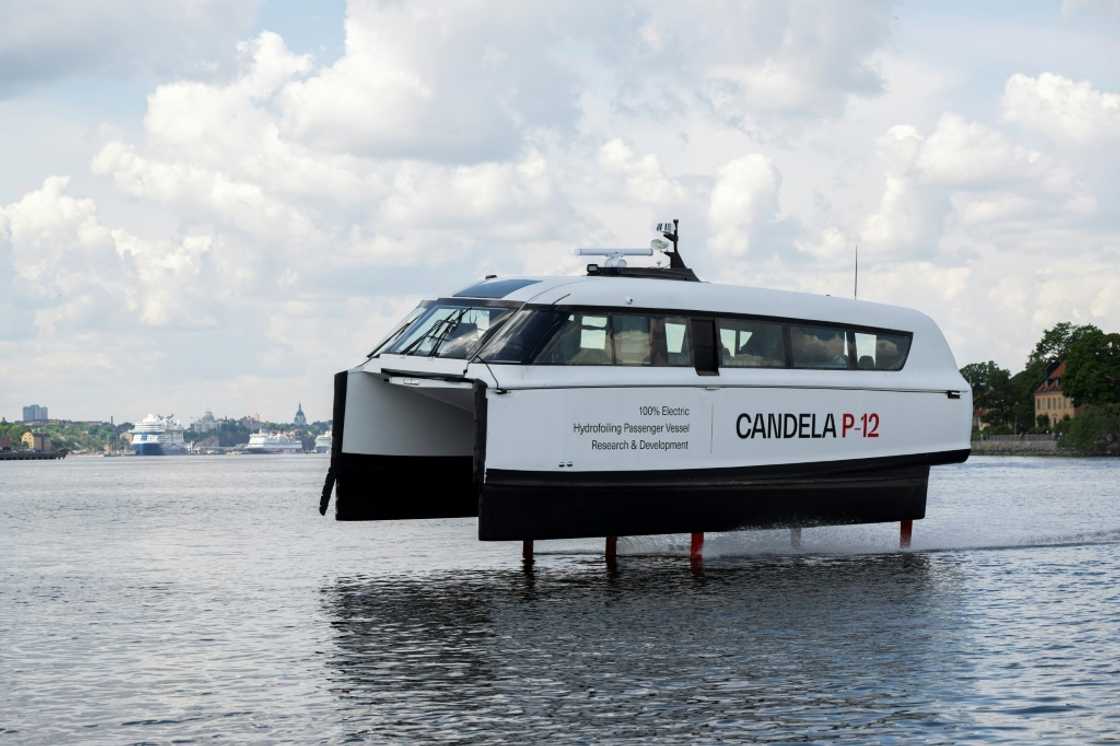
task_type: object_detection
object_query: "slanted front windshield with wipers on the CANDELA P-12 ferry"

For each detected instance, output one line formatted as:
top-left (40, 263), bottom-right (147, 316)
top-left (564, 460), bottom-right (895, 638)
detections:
top-left (381, 300), bottom-right (513, 360)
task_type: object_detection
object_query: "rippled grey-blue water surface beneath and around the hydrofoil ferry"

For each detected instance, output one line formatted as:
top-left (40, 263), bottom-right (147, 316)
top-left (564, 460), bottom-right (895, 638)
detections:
top-left (0, 456), bottom-right (1120, 744)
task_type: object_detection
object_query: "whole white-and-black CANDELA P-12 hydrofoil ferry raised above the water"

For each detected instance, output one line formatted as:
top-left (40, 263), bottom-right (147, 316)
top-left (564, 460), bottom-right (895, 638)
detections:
top-left (320, 222), bottom-right (972, 547)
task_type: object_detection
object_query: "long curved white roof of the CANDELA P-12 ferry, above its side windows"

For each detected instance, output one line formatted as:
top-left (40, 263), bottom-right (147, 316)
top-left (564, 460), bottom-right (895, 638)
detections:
top-left (455, 276), bottom-right (935, 332)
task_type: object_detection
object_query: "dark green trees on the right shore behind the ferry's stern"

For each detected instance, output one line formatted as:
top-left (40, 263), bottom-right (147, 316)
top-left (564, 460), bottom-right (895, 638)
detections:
top-left (961, 321), bottom-right (1120, 453)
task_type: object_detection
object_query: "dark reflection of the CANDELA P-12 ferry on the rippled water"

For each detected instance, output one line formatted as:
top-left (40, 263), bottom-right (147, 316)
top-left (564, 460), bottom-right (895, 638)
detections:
top-left (323, 554), bottom-right (981, 742)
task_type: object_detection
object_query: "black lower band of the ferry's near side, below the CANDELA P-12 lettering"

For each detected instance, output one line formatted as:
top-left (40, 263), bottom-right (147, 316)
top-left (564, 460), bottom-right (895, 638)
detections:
top-left (478, 450), bottom-right (969, 541)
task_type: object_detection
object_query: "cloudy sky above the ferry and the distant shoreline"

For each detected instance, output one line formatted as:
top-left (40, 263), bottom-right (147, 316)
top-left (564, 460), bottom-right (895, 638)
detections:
top-left (0, 0), bottom-right (1120, 422)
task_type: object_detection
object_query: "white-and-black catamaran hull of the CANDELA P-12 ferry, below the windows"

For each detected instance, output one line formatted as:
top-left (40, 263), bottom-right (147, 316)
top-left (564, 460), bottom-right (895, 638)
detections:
top-left (322, 371), bottom-right (971, 540)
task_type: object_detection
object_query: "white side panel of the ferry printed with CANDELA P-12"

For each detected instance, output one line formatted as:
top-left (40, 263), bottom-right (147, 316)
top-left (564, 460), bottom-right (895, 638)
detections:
top-left (486, 386), bottom-right (971, 472)
